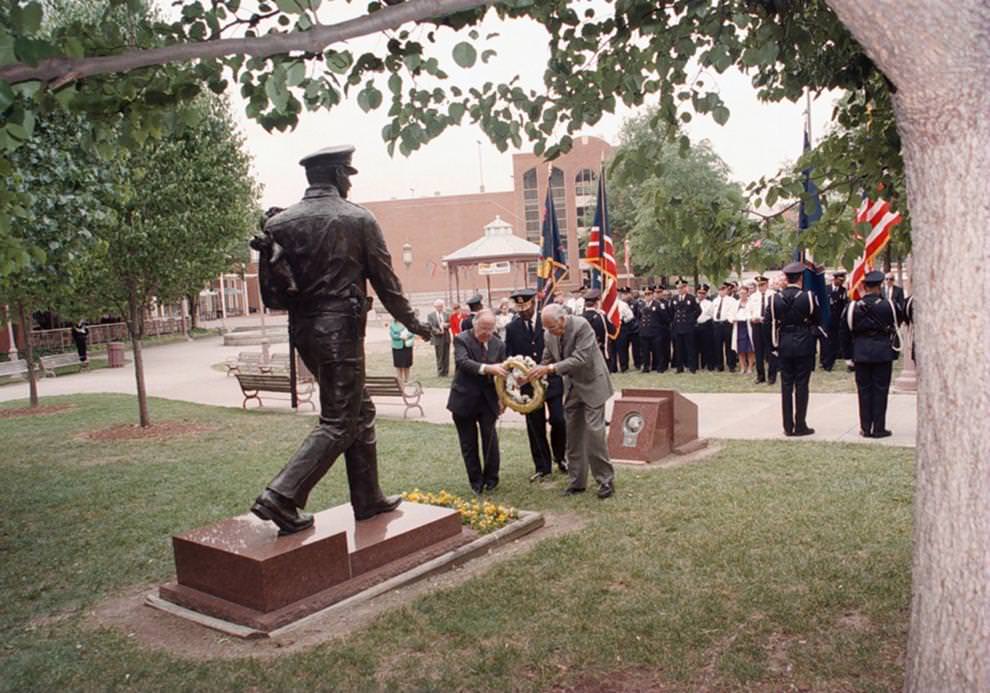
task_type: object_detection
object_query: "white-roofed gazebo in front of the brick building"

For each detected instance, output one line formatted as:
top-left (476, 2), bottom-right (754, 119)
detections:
top-left (443, 214), bottom-right (542, 305)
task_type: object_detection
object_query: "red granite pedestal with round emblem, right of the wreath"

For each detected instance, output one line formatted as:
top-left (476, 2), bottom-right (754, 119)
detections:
top-left (608, 388), bottom-right (708, 464)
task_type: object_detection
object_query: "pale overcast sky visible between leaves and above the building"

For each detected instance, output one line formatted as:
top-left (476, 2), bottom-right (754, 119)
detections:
top-left (223, 3), bottom-right (832, 207)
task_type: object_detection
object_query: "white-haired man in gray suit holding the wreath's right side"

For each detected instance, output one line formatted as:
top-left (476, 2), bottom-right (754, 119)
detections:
top-left (529, 303), bottom-right (615, 498)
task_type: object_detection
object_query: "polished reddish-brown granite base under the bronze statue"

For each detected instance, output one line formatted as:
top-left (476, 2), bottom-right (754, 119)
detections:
top-left (159, 502), bottom-right (464, 632)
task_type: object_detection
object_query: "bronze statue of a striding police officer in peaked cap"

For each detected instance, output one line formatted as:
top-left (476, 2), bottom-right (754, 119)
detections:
top-left (251, 146), bottom-right (430, 533)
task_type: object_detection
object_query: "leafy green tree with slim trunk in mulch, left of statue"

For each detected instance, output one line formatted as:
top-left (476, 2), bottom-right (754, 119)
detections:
top-left (87, 97), bottom-right (258, 426)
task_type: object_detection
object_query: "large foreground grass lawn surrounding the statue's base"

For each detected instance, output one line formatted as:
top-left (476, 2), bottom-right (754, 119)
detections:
top-left (0, 395), bottom-right (913, 691)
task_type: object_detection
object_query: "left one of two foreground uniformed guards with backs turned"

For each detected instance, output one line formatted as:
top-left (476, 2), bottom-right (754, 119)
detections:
top-left (772, 262), bottom-right (821, 436)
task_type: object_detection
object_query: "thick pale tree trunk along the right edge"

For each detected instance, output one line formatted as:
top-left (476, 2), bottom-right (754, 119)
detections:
top-left (829, 0), bottom-right (990, 691)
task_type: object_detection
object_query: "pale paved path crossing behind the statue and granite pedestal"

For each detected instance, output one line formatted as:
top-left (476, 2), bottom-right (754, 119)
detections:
top-left (0, 327), bottom-right (917, 446)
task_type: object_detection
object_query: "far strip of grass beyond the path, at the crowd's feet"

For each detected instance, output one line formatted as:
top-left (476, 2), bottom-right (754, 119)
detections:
top-left (367, 341), bottom-right (900, 393)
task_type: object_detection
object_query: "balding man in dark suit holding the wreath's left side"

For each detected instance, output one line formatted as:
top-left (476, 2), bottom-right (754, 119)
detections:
top-left (447, 309), bottom-right (506, 493)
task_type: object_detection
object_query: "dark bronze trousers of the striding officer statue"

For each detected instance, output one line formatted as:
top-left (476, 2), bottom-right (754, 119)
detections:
top-left (268, 313), bottom-right (385, 514)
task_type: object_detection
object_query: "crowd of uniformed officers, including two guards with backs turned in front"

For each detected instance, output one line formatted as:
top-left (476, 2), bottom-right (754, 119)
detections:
top-left (557, 262), bottom-right (912, 438)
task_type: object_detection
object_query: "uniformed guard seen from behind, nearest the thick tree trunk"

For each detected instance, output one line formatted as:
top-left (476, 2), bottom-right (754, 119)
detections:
top-left (840, 271), bottom-right (901, 438)
